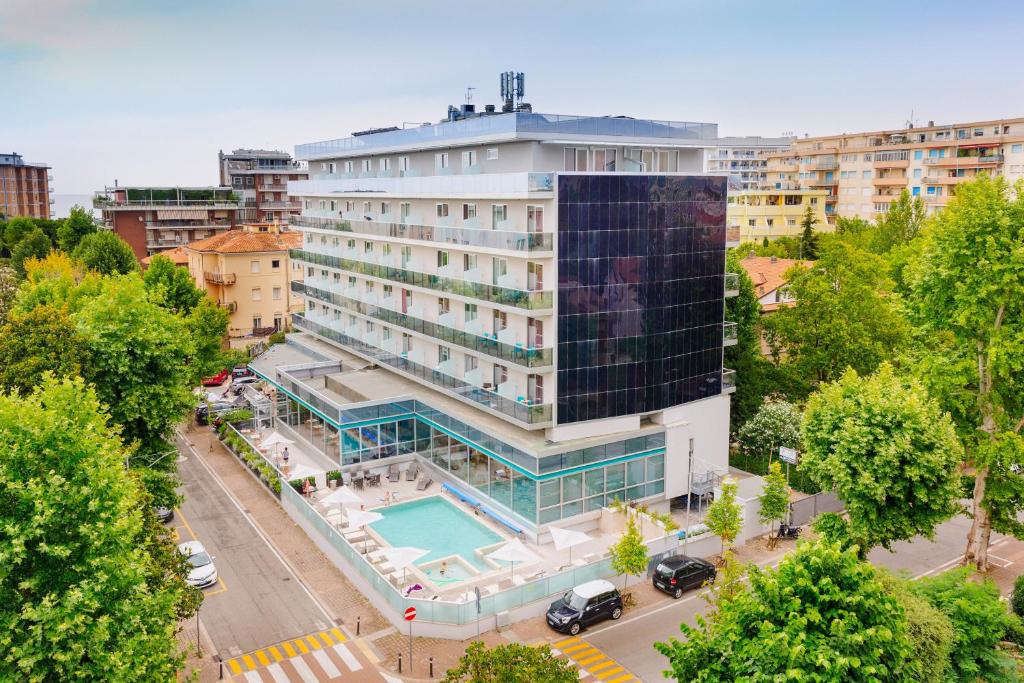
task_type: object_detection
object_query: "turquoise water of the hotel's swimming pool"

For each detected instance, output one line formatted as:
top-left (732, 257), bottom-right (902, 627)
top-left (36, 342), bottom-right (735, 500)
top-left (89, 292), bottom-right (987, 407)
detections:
top-left (371, 496), bottom-right (503, 570)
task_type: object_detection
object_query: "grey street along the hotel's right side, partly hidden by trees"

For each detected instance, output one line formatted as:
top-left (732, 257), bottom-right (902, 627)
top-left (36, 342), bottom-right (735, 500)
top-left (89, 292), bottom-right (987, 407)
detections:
top-left (583, 517), bottom-right (1024, 681)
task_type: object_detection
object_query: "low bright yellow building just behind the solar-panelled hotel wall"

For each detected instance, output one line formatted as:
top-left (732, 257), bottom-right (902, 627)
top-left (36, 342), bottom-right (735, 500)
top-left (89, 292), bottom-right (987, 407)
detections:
top-left (727, 189), bottom-right (836, 242)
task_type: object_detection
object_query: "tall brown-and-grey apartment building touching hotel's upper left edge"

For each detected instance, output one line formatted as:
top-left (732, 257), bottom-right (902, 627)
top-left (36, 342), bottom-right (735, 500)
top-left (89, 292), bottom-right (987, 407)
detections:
top-left (217, 150), bottom-right (309, 223)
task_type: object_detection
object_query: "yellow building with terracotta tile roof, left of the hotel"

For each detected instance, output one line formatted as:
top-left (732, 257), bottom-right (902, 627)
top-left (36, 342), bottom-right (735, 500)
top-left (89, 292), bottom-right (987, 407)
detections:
top-left (185, 223), bottom-right (304, 338)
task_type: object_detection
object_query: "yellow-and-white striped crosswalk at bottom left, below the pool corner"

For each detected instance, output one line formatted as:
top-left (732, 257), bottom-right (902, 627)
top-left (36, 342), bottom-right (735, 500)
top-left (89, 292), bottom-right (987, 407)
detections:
top-left (224, 628), bottom-right (380, 683)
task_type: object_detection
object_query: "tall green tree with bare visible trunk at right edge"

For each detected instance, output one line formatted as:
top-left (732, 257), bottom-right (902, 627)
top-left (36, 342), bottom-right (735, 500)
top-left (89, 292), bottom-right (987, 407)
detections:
top-left (906, 176), bottom-right (1024, 571)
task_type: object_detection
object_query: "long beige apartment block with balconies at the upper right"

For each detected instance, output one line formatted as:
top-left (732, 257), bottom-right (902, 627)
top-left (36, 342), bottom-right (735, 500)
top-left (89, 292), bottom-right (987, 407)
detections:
top-left (768, 119), bottom-right (1024, 219)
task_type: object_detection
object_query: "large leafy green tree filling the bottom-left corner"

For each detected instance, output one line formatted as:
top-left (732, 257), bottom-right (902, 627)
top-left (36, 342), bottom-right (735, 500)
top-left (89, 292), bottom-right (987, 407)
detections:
top-left (0, 379), bottom-right (197, 682)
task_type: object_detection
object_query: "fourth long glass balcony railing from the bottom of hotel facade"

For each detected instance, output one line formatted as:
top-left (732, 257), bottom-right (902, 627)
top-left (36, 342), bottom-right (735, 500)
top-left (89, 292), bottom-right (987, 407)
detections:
top-left (291, 216), bottom-right (553, 252)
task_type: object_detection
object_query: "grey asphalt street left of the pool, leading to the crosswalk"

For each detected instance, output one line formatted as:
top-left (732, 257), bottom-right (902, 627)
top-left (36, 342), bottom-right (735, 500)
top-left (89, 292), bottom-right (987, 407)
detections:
top-left (172, 430), bottom-right (335, 659)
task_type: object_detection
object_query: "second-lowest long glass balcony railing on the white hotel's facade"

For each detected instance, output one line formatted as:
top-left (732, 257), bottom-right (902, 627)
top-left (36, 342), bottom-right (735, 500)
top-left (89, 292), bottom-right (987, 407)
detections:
top-left (292, 281), bottom-right (552, 368)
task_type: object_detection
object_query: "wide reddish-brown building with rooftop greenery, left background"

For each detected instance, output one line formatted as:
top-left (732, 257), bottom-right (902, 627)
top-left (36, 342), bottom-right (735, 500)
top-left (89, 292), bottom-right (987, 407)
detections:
top-left (92, 185), bottom-right (241, 260)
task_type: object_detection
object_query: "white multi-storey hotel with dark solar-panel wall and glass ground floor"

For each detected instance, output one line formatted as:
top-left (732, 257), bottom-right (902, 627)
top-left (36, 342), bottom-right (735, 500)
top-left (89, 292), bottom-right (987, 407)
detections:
top-left (248, 100), bottom-right (737, 538)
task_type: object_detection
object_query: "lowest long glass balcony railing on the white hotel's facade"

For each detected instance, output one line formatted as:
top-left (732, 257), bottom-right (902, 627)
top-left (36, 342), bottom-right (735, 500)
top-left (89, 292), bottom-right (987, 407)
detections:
top-left (292, 313), bottom-right (551, 424)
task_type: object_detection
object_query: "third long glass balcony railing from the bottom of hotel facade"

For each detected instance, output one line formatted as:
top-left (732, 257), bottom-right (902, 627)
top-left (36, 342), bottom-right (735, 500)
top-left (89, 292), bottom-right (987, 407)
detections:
top-left (289, 249), bottom-right (552, 310)
